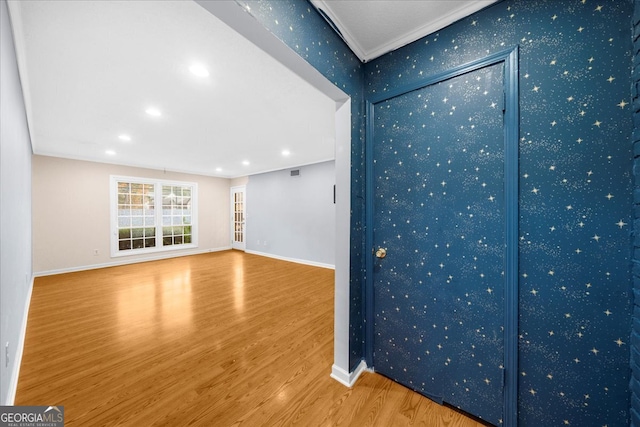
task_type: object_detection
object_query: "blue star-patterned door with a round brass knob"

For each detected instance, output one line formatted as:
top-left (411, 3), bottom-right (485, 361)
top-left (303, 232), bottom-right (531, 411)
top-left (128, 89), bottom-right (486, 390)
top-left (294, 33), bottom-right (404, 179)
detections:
top-left (369, 63), bottom-right (517, 425)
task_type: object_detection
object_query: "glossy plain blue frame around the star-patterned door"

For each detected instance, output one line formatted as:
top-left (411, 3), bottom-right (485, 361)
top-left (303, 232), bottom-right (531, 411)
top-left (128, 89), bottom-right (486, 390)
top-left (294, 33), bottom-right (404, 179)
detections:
top-left (364, 46), bottom-right (520, 427)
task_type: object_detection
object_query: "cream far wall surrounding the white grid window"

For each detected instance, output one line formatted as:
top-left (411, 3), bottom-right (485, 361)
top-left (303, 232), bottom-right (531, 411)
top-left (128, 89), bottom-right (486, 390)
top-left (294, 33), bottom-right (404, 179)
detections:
top-left (33, 156), bottom-right (230, 275)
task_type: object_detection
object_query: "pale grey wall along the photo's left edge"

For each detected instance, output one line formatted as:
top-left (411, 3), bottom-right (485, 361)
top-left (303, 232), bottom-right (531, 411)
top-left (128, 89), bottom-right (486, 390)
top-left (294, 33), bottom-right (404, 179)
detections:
top-left (0, 0), bottom-right (32, 405)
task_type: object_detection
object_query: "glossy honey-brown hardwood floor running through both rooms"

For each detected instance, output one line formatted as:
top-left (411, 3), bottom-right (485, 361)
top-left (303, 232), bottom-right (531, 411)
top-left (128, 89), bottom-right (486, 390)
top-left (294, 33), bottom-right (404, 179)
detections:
top-left (15, 251), bottom-right (481, 427)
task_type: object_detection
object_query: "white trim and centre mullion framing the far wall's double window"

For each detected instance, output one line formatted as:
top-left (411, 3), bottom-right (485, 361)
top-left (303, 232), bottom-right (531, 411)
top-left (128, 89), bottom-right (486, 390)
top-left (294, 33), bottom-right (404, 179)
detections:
top-left (109, 175), bottom-right (199, 258)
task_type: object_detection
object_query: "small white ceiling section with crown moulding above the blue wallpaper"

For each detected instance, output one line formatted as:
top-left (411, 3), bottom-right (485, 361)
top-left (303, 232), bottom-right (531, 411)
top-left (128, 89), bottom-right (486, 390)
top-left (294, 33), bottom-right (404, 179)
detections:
top-left (310, 0), bottom-right (499, 62)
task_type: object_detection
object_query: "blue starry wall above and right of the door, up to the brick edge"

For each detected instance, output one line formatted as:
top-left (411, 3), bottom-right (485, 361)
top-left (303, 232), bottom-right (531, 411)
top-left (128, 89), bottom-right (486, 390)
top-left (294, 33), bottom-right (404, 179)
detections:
top-left (366, 1), bottom-right (632, 426)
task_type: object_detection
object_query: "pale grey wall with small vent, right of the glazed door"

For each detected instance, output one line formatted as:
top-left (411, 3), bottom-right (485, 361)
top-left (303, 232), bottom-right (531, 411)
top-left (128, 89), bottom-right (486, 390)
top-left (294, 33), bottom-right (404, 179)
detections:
top-left (246, 161), bottom-right (336, 268)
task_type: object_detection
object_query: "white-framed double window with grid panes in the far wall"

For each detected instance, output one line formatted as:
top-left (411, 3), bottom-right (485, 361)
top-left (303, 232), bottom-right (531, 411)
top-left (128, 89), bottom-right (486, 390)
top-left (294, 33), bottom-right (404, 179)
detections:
top-left (111, 176), bottom-right (198, 256)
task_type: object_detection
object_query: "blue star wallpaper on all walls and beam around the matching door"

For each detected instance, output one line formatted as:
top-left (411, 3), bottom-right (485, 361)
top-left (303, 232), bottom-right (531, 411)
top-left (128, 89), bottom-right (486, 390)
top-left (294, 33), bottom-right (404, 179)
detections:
top-left (241, 0), bottom-right (640, 427)
